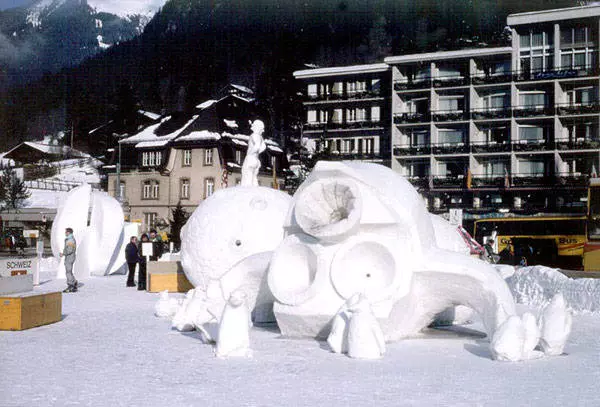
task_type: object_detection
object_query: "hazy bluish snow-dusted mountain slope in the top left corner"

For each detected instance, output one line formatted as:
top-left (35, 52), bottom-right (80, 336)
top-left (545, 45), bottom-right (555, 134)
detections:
top-left (0, 0), bottom-right (167, 87)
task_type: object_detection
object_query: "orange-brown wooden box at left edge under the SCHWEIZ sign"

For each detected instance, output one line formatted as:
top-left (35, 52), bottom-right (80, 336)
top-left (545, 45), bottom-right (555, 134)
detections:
top-left (0, 291), bottom-right (62, 331)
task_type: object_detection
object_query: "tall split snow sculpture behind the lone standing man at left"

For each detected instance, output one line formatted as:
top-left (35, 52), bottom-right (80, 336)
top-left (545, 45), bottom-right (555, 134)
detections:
top-left (50, 184), bottom-right (124, 279)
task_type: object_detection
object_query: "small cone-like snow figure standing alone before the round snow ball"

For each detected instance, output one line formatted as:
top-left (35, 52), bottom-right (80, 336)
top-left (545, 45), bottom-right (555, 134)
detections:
top-left (215, 290), bottom-right (252, 358)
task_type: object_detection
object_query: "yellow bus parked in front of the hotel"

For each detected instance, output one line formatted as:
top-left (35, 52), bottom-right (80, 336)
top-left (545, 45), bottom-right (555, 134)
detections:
top-left (474, 217), bottom-right (584, 270)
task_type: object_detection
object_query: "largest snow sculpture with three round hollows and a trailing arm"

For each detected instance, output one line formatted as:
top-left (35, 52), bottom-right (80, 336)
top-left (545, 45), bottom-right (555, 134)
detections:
top-left (268, 162), bottom-right (515, 356)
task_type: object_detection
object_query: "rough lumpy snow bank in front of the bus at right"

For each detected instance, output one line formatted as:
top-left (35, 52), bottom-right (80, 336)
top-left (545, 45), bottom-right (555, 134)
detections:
top-left (506, 266), bottom-right (600, 313)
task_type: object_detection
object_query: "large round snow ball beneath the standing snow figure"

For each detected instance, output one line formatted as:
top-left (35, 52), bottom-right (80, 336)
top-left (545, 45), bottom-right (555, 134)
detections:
top-left (181, 186), bottom-right (291, 325)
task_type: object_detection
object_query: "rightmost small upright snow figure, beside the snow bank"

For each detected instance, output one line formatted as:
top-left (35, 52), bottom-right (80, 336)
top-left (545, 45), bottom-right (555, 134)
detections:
top-left (540, 293), bottom-right (572, 355)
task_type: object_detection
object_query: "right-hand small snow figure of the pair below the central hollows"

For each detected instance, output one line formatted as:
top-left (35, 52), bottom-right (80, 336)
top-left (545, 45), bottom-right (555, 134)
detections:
top-left (348, 294), bottom-right (385, 359)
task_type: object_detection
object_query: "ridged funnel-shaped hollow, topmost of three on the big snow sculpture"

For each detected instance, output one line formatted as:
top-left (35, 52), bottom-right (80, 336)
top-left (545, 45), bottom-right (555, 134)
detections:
top-left (294, 178), bottom-right (362, 241)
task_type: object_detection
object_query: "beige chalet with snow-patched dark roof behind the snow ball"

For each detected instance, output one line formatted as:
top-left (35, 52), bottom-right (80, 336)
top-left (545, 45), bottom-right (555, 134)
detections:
top-left (107, 92), bottom-right (288, 230)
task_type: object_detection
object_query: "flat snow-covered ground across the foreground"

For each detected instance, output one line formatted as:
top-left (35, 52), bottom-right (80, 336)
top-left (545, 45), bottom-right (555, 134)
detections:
top-left (0, 261), bottom-right (600, 407)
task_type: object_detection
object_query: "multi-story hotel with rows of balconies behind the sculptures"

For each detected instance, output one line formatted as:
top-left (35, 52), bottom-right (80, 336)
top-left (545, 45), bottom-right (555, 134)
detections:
top-left (295, 5), bottom-right (600, 220)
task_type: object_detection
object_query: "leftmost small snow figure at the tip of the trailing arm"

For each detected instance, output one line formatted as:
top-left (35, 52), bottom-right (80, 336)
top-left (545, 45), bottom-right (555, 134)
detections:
top-left (490, 315), bottom-right (525, 362)
